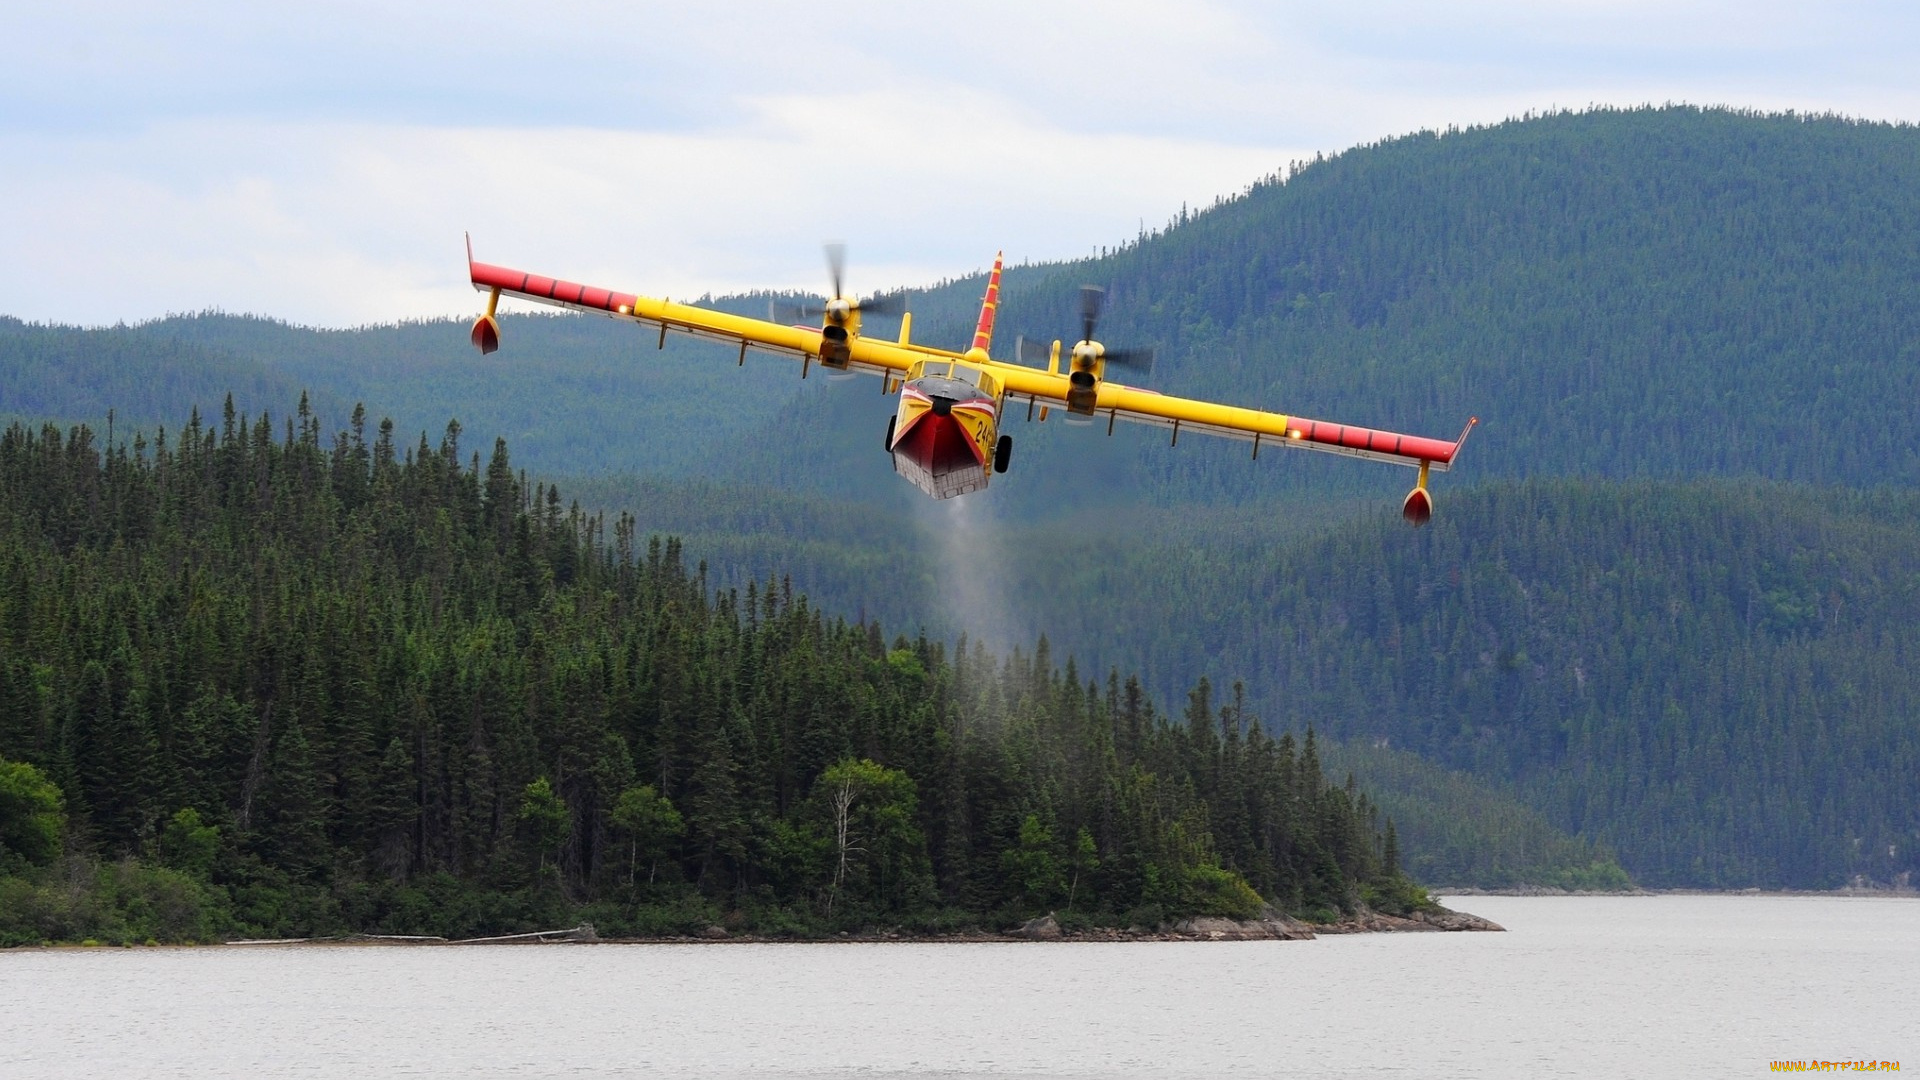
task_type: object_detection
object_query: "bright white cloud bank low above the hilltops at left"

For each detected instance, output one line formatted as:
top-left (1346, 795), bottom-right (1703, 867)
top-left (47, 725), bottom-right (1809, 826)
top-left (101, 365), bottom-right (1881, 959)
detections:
top-left (0, 96), bottom-right (1277, 325)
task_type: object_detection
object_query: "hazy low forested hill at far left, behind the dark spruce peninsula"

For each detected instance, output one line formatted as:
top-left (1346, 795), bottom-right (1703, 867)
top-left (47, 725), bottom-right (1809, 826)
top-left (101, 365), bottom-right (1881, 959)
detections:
top-left (0, 305), bottom-right (799, 475)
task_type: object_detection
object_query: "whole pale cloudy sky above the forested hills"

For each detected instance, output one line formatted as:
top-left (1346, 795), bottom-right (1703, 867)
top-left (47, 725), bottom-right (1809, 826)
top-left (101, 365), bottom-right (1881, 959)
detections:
top-left (0, 0), bottom-right (1920, 327)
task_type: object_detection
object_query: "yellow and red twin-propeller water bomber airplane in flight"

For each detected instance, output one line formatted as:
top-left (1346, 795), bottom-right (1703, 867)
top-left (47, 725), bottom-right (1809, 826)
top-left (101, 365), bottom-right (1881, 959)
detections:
top-left (467, 240), bottom-right (1478, 525)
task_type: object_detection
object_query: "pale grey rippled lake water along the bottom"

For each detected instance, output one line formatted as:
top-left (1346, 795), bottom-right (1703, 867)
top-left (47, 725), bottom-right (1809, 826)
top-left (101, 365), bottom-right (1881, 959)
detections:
top-left (0, 896), bottom-right (1920, 1080)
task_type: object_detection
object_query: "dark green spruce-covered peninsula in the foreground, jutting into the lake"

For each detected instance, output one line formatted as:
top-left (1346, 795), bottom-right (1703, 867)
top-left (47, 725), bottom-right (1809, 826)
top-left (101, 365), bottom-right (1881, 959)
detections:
top-left (0, 402), bottom-right (1427, 944)
